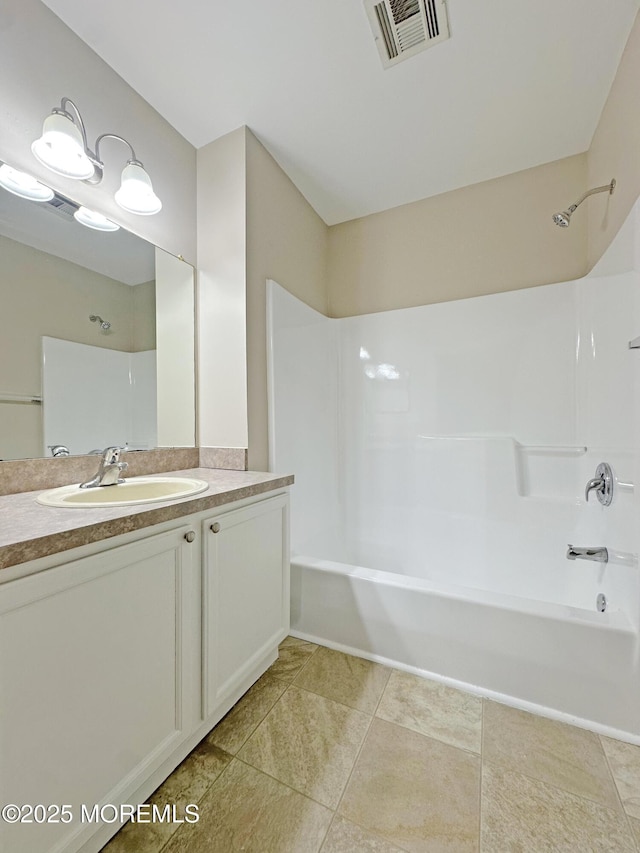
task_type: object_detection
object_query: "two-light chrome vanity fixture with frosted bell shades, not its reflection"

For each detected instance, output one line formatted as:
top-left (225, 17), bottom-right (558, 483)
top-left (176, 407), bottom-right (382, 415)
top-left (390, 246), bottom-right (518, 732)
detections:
top-left (31, 98), bottom-right (162, 216)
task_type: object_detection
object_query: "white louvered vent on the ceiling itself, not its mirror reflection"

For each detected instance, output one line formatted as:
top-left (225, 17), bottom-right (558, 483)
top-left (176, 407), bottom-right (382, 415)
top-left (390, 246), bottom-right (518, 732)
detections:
top-left (364, 0), bottom-right (449, 68)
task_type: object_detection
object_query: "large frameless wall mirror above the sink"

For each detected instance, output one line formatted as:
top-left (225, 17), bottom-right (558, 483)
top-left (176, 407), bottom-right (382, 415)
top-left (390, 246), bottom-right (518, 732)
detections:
top-left (0, 163), bottom-right (195, 461)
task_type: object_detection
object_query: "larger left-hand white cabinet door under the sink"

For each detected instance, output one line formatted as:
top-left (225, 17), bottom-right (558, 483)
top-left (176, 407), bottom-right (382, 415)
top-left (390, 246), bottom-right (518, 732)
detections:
top-left (0, 524), bottom-right (199, 853)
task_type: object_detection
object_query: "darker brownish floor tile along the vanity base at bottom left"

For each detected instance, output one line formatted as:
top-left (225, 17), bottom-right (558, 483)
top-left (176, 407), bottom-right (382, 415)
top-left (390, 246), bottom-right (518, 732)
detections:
top-left (103, 737), bottom-right (231, 853)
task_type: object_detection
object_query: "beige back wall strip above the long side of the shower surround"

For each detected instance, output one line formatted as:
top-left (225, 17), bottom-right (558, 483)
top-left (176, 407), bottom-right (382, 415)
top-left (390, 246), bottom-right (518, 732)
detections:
top-left (329, 154), bottom-right (587, 317)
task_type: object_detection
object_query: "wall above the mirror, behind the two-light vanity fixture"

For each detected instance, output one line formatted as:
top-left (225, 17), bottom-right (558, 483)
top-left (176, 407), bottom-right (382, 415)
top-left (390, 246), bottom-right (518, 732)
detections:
top-left (0, 0), bottom-right (196, 263)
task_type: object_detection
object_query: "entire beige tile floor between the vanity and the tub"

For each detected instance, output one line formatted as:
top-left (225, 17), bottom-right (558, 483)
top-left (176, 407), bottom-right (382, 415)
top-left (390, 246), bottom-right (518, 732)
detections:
top-left (104, 637), bottom-right (640, 853)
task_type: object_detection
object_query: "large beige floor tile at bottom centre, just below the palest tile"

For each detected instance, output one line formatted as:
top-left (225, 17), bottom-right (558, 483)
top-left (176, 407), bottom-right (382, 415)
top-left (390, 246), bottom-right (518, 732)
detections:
top-left (339, 718), bottom-right (480, 853)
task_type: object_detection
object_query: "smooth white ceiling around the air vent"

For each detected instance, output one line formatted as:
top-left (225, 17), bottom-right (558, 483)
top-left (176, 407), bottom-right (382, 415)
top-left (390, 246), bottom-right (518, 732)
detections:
top-left (44, 0), bottom-right (640, 224)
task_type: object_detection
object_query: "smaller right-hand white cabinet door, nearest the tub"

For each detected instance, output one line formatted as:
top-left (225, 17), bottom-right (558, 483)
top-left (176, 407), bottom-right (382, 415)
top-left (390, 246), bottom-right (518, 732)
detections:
top-left (203, 495), bottom-right (289, 719)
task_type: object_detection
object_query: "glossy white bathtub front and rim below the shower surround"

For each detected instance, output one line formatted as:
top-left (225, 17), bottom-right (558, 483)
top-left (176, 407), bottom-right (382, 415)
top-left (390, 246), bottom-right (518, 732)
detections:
top-left (291, 555), bottom-right (640, 744)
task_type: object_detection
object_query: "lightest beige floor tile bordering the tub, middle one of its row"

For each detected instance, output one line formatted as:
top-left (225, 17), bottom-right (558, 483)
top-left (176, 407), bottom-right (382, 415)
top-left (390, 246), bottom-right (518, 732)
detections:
top-left (376, 670), bottom-right (482, 752)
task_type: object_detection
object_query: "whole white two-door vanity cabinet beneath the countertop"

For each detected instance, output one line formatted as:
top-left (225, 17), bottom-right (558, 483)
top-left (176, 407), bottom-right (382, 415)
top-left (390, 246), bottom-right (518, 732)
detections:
top-left (0, 490), bottom-right (289, 853)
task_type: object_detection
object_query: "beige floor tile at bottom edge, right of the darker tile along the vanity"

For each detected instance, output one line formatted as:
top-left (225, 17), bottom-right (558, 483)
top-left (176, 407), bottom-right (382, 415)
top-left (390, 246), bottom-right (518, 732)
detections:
top-left (162, 759), bottom-right (332, 853)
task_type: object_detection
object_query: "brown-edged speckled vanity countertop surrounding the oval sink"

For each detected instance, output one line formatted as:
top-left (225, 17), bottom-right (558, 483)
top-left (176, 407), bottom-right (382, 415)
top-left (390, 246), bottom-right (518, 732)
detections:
top-left (0, 468), bottom-right (293, 570)
